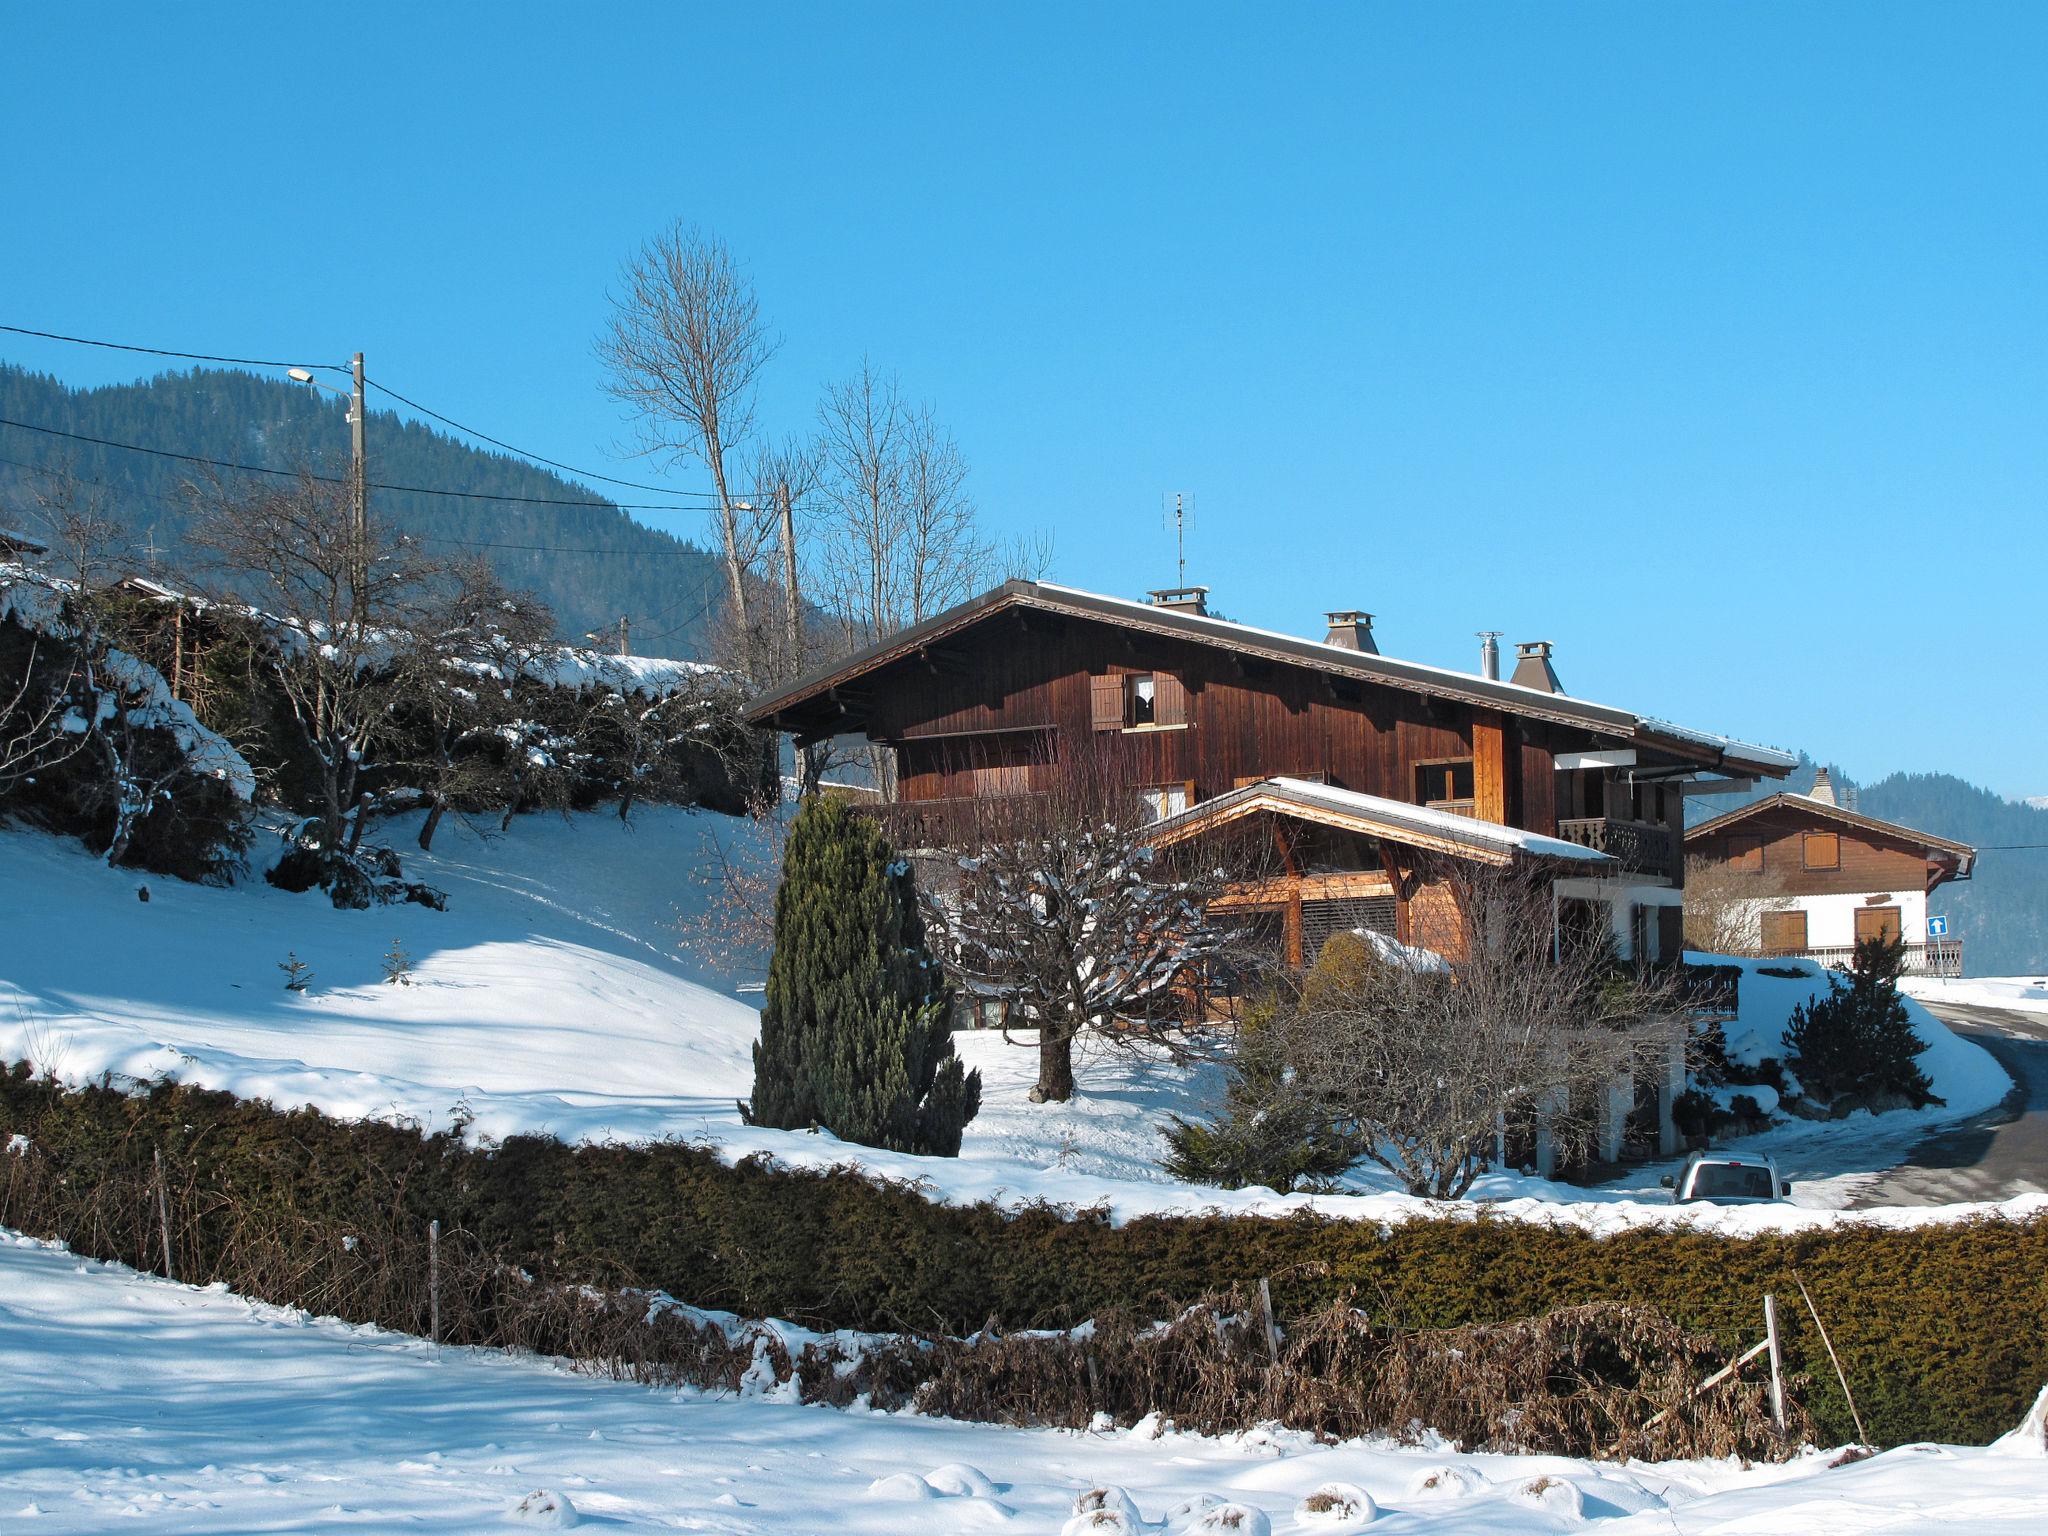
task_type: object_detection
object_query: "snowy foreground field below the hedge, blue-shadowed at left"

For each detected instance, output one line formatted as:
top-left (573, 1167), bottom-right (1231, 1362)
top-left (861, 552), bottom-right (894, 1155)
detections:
top-left (0, 1231), bottom-right (2048, 1536)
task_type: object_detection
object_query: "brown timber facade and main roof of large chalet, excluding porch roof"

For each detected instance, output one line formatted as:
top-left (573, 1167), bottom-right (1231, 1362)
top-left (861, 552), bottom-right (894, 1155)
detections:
top-left (750, 582), bottom-right (1792, 954)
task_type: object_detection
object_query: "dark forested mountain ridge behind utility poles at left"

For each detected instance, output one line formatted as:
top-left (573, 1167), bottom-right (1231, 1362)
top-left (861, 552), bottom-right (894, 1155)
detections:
top-left (0, 362), bottom-right (723, 657)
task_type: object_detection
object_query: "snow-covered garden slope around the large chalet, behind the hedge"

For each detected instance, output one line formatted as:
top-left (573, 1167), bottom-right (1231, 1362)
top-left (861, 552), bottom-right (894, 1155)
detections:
top-left (0, 807), bottom-right (2044, 1233)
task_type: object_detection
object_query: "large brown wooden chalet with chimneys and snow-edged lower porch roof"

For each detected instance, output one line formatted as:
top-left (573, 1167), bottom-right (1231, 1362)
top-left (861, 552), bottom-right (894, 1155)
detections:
top-left (750, 582), bottom-right (1794, 965)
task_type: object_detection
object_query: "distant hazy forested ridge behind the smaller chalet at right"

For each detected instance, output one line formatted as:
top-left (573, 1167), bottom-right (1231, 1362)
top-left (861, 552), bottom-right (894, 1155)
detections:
top-left (1686, 752), bottom-right (2048, 977)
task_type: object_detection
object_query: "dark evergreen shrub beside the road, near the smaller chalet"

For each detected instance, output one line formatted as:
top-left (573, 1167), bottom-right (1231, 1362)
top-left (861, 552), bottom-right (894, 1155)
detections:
top-left (1786, 938), bottom-right (1942, 1114)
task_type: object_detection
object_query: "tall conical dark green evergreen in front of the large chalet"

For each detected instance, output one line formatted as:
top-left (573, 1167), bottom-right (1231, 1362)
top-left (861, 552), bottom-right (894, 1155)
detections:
top-left (741, 797), bottom-right (981, 1157)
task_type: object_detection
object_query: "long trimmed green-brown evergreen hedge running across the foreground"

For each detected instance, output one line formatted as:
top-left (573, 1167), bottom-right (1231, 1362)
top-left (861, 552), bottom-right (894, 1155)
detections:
top-left (0, 1067), bottom-right (2048, 1446)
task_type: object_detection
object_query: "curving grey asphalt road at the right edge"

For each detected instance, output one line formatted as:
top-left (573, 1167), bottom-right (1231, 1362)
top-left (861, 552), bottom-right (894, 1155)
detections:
top-left (1855, 999), bottom-right (2048, 1206)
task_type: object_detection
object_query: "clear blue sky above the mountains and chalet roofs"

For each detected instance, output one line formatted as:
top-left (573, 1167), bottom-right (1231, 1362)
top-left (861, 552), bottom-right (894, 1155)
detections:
top-left (0, 4), bottom-right (2048, 795)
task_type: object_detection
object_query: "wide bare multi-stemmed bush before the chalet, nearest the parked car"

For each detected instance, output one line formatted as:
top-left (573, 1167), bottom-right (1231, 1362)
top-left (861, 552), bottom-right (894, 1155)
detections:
top-left (1257, 860), bottom-right (1683, 1200)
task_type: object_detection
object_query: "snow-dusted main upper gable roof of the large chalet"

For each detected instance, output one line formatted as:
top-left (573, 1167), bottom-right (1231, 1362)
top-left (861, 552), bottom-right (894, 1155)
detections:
top-left (748, 580), bottom-right (1798, 776)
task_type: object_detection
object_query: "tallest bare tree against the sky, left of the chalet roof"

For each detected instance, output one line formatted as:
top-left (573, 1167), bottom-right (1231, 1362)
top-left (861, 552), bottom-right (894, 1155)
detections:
top-left (598, 221), bottom-right (776, 678)
